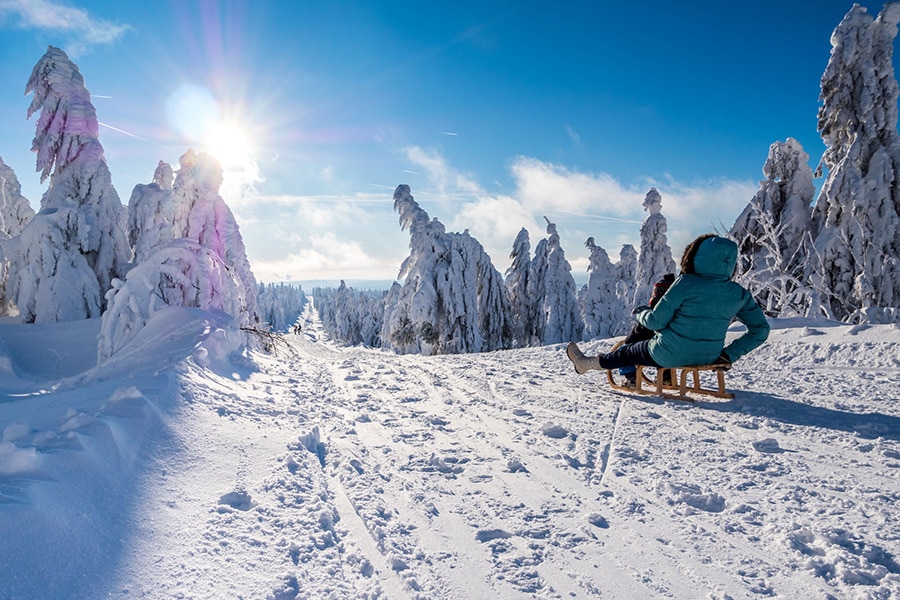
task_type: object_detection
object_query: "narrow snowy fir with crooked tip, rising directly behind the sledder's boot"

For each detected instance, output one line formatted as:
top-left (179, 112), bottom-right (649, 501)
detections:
top-left (526, 217), bottom-right (584, 345)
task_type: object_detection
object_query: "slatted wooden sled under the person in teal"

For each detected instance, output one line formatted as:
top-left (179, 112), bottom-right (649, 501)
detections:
top-left (606, 342), bottom-right (734, 402)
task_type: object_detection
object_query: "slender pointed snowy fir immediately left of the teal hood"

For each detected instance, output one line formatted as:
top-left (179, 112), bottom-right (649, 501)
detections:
top-left (631, 188), bottom-right (675, 307)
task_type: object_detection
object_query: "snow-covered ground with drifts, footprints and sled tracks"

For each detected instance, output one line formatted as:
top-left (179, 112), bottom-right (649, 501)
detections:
top-left (0, 309), bottom-right (900, 600)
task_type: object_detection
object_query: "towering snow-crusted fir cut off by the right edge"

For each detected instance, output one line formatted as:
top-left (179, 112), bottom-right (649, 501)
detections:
top-left (812, 2), bottom-right (900, 319)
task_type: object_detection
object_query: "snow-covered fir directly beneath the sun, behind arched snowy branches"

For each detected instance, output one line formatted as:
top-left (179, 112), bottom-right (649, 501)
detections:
top-left (172, 150), bottom-right (259, 323)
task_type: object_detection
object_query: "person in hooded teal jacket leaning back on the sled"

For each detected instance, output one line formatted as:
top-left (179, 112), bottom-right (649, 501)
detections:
top-left (566, 234), bottom-right (769, 374)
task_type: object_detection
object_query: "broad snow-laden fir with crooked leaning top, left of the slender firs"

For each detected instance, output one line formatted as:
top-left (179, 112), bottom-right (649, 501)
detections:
top-left (382, 185), bottom-right (510, 354)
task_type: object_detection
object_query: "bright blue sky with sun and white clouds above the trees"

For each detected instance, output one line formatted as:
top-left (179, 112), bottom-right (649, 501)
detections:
top-left (0, 0), bottom-right (882, 281)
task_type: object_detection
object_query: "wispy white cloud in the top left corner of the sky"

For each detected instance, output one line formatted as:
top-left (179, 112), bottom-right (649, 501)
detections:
top-left (0, 0), bottom-right (131, 54)
